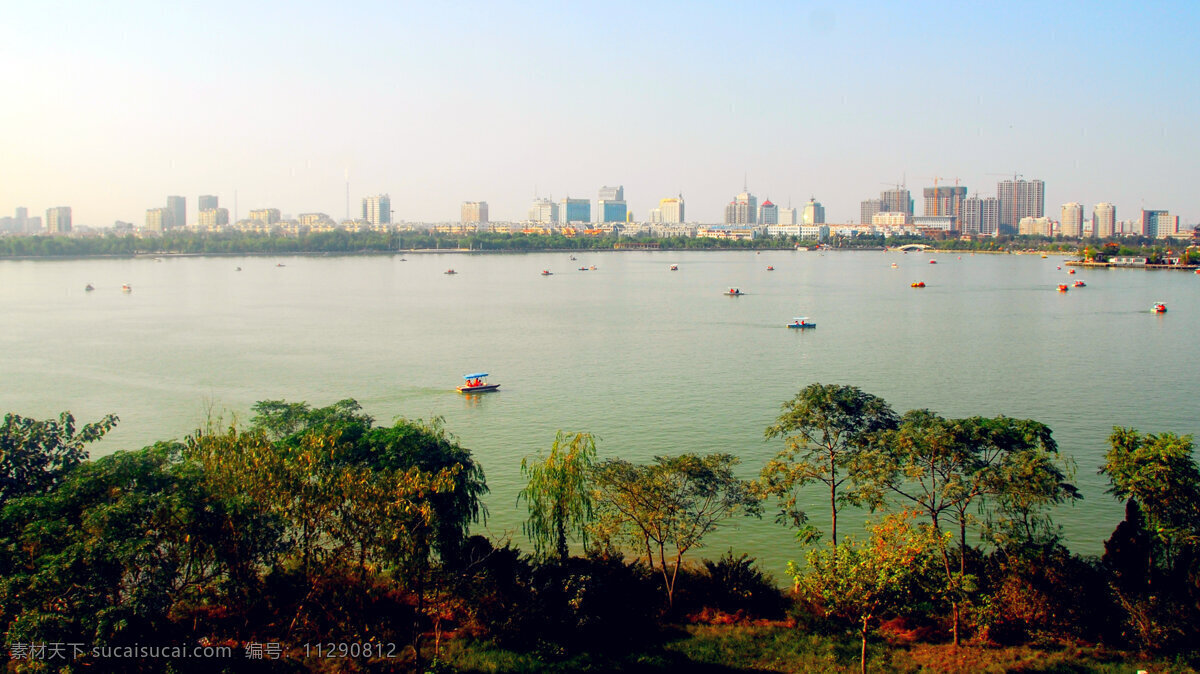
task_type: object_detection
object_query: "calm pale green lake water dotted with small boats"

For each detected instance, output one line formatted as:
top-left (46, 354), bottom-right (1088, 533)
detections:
top-left (0, 251), bottom-right (1200, 577)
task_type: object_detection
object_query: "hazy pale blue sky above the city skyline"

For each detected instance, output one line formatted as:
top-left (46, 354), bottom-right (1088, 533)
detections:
top-left (0, 0), bottom-right (1200, 227)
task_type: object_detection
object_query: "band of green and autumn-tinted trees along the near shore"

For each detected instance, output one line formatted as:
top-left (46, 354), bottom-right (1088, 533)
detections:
top-left (0, 384), bottom-right (1200, 670)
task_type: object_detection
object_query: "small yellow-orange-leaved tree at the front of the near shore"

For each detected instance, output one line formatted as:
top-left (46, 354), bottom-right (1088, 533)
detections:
top-left (787, 513), bottom-right (944, 673)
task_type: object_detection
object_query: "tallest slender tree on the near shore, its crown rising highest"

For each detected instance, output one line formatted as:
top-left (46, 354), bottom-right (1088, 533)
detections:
top-left (760, 384), bottom-right (896, 546)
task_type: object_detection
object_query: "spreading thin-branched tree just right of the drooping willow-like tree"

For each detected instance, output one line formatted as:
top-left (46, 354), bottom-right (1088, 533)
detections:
top-left (593, 453), bottom-right (762, 606)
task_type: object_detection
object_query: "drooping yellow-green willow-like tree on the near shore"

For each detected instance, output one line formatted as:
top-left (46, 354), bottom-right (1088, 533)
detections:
top-left (517, 431), bottom-right (596, 562)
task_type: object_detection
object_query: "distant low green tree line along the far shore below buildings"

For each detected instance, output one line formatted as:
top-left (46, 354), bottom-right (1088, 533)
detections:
top-left (0, 225), bottom-right (1200, 256)
